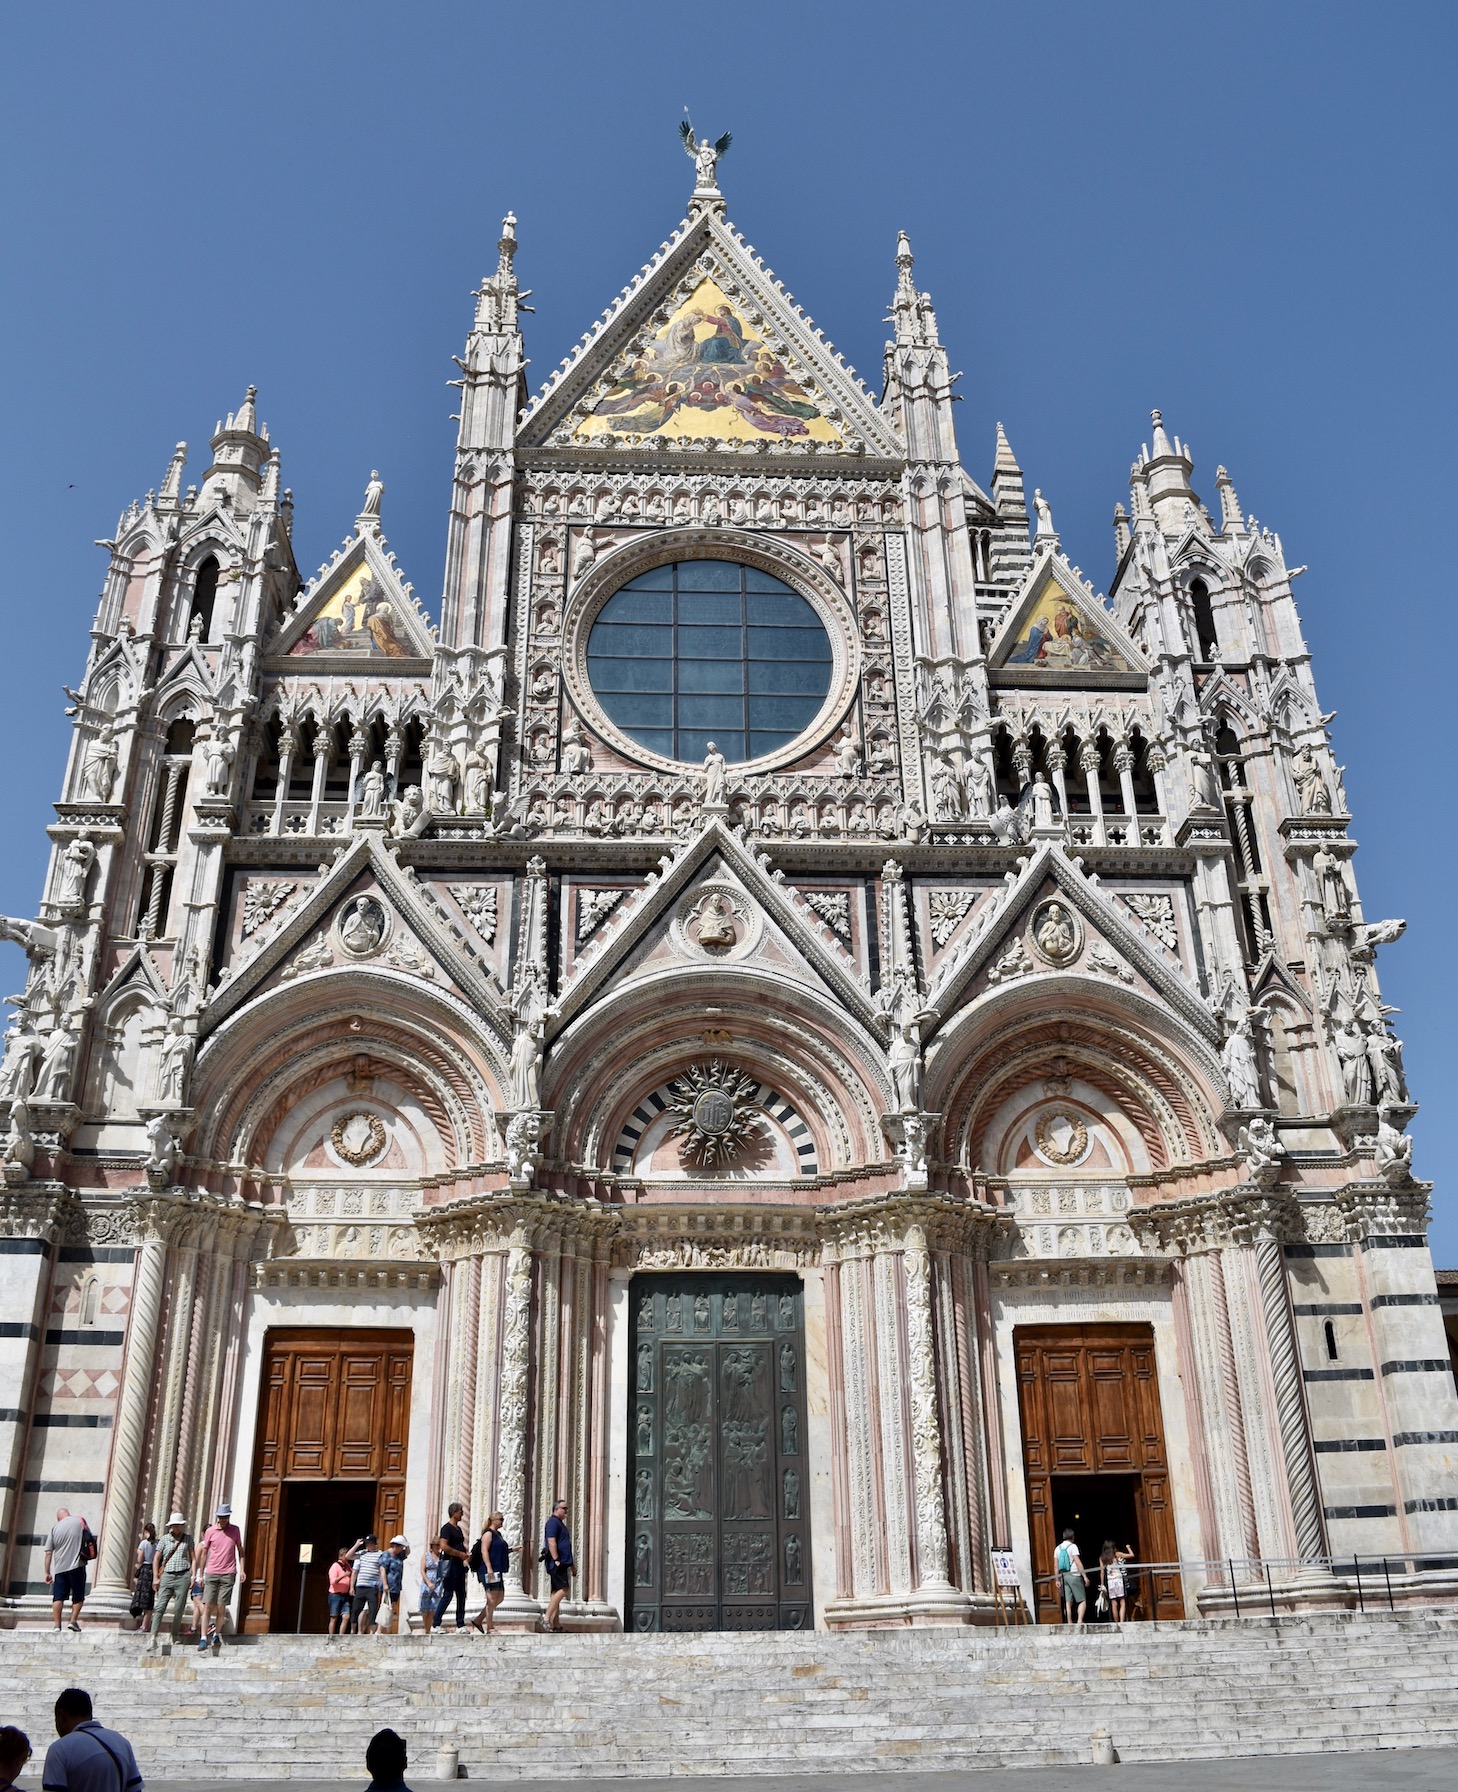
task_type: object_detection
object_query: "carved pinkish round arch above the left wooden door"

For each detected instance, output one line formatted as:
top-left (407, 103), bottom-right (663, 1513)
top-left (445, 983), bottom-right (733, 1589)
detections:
top-left (192, 968), bottom-right (509, 1179)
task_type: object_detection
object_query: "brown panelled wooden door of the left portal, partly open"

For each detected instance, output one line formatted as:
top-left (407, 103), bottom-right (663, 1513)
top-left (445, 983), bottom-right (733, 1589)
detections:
top-left (244, 1328), bottom-right (414, 1631)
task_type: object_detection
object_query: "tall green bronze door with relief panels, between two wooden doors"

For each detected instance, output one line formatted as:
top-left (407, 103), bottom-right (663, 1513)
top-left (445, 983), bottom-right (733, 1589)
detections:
top-left (627, 1274), bottom-right (811, 1631)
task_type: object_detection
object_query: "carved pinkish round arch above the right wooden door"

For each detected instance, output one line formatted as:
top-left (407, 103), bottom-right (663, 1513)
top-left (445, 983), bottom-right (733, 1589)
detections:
top-left (924, 975), bottom-right (1227, 1176)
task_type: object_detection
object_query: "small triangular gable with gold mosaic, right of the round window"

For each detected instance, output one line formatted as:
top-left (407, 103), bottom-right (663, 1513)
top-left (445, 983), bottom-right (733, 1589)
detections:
top-left (987, 548), bottom-right (1148, 690)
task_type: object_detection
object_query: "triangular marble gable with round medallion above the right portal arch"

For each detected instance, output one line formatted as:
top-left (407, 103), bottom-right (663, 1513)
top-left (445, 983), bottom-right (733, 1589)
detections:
top-left (926, 842), bottom-right (1218, 1041)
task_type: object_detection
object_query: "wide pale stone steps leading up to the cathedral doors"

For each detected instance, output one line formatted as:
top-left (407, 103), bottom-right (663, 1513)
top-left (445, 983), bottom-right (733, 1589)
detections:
top-left (0, 1611), bottom-right (1458, 1781)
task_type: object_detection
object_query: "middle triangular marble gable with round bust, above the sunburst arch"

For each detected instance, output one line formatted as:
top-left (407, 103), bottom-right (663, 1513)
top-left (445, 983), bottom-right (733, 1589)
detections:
top-left (550, 819), bottom-right (876, 1034)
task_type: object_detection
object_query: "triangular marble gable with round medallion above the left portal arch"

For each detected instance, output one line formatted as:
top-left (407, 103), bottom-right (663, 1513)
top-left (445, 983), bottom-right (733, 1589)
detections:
top-left (202, 833), bottom-right (505, 1034)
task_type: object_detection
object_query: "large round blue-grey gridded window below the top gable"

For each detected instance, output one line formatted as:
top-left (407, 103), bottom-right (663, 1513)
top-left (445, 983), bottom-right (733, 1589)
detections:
top-left (587, 559), bottom-right (831, 763)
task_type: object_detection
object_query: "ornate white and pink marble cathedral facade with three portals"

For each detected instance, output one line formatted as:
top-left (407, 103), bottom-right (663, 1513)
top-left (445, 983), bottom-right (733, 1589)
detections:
top-left (0, 143), bottom-right (1458, 1631)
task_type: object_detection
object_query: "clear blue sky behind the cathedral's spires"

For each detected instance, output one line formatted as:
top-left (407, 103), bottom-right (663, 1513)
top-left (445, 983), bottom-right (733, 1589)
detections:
top-left (0, 0), bottom-right (1458, 1265)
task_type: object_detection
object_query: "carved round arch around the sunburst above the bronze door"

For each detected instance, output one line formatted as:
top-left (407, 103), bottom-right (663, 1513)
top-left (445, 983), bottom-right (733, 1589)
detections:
top-left (545, 964), bottom-right (890, 1176)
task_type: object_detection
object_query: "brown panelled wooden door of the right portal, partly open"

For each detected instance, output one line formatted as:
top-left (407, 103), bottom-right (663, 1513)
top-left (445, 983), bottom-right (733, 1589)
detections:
top-left (1012, 1324), bottom-right (1184, 1624)
